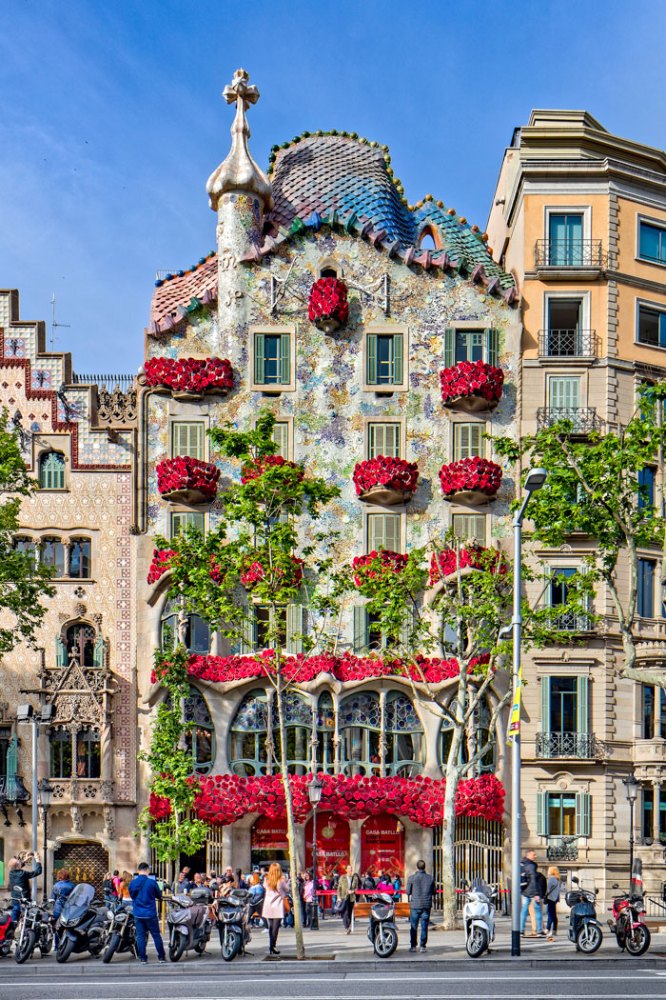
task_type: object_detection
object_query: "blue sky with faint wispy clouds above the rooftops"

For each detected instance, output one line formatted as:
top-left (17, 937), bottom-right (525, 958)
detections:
top-left (0, 0), bottom-right (666, 372)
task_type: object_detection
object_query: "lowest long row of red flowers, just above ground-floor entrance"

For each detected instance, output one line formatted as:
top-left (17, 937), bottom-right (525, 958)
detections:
top-left (184, 774), bottom-right (504, 827)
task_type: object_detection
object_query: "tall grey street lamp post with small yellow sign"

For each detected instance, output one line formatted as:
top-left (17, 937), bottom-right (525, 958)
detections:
top-left (511, 469), bottom-right (548, 956)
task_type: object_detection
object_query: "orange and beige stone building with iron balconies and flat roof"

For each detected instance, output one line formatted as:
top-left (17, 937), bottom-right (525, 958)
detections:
top-left (488, 110), bottom-right (666, 898)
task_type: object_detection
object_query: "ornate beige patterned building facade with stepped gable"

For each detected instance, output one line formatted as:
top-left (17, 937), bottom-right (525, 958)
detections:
top-left (0, 291), bottom-right (137, 888)
